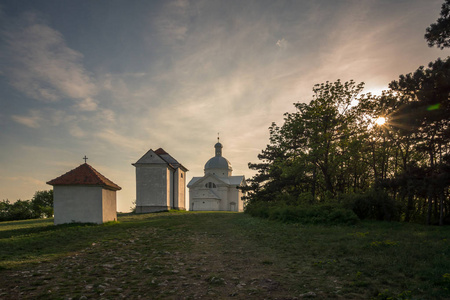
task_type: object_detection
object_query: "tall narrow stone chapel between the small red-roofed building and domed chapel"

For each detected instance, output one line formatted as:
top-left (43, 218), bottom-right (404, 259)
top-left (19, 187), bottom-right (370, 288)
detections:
top-left (132, 148), bottom-right (188, 213)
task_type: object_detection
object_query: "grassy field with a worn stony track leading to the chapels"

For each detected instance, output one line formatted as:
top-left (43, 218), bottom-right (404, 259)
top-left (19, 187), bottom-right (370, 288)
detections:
top-left (0, 212), bottom-right (450, 299)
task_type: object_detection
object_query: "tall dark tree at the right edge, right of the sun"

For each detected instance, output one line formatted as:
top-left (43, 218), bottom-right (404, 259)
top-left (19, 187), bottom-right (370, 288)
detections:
top-left (389, 58), bottom-right (450, 224)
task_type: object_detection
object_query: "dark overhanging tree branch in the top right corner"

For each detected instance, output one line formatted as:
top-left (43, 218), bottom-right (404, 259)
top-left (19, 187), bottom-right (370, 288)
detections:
top-left (425, 0), bottom-right (450, 49)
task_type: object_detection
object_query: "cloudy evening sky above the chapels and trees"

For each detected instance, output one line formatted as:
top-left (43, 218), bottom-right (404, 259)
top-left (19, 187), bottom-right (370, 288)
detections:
top-left (0, 0), bottom-right (450, 212)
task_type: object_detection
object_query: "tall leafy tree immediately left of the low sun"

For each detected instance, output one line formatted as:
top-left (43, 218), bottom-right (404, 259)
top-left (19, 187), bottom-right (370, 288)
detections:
top-left (282, 80), bottom-right (364, 200)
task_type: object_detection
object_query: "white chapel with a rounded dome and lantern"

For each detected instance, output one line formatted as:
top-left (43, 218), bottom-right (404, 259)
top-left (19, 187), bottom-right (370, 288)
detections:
top-left (187, 139), bottom-right (246, 211)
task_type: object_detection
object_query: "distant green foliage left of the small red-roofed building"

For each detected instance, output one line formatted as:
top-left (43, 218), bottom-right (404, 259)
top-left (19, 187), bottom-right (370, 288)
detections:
top-left (0, 190), bottom-right (53, 221)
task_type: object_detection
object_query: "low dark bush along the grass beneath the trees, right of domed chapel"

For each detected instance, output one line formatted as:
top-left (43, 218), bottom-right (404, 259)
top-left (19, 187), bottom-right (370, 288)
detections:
top-left (245, 202), bottom-right (359, 225)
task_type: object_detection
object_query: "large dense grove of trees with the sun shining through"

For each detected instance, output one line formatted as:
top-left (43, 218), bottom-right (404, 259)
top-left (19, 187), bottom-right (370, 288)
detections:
top-left (245, 58), bottom-right (450, 224)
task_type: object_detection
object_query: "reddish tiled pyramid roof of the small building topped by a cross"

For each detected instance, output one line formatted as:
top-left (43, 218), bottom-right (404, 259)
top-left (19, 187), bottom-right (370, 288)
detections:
top-left (47, 163), bottom-right (122, 191)
